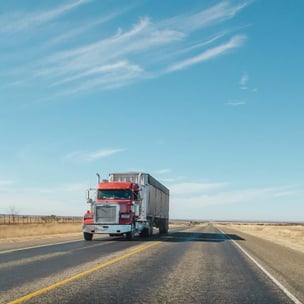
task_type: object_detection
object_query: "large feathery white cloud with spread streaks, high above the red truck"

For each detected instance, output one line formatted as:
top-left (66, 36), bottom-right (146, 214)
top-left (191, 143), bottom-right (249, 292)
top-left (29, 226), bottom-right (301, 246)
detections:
top-left (35, 18), bottom-right (183, 91)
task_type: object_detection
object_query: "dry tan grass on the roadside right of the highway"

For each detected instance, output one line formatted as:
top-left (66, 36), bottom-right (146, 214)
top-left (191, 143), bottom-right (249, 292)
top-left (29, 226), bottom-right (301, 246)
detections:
top-left (221, 224), bottom-right (304, 253)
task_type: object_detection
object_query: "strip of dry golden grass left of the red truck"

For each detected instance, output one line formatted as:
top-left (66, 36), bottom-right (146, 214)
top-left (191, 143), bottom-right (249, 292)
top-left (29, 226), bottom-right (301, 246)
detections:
top-left (0, 223), bottom-right (81, 239)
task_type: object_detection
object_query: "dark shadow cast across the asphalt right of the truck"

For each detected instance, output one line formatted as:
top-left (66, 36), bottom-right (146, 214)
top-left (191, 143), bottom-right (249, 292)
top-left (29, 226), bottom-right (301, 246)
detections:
top-left (160, 232), bottom-right (245, 242)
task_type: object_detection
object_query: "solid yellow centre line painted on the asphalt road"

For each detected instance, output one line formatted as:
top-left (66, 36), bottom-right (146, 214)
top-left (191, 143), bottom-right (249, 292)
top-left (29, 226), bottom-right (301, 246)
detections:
top-left (9, 241), bottom-right (160, 304)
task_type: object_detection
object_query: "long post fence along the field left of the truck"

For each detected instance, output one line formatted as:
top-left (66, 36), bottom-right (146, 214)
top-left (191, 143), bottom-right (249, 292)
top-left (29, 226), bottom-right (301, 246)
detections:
top-left (0, 214), bottom-right (82, 225)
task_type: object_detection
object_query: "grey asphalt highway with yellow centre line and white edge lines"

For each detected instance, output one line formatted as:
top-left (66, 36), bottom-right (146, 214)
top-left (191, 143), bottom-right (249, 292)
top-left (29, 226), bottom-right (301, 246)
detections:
top-left (0, 225), bottom-right (304, 304)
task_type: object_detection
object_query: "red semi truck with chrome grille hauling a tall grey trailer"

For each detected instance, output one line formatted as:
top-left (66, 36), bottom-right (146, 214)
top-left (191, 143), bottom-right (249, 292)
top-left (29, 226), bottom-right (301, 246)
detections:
top-left (82, 172), bottom-right (169, 241)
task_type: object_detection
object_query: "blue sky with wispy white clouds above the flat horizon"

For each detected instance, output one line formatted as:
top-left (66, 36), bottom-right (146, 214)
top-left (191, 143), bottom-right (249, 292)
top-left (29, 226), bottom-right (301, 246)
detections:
top-left (0, 0), bottom-right (304, 221)
